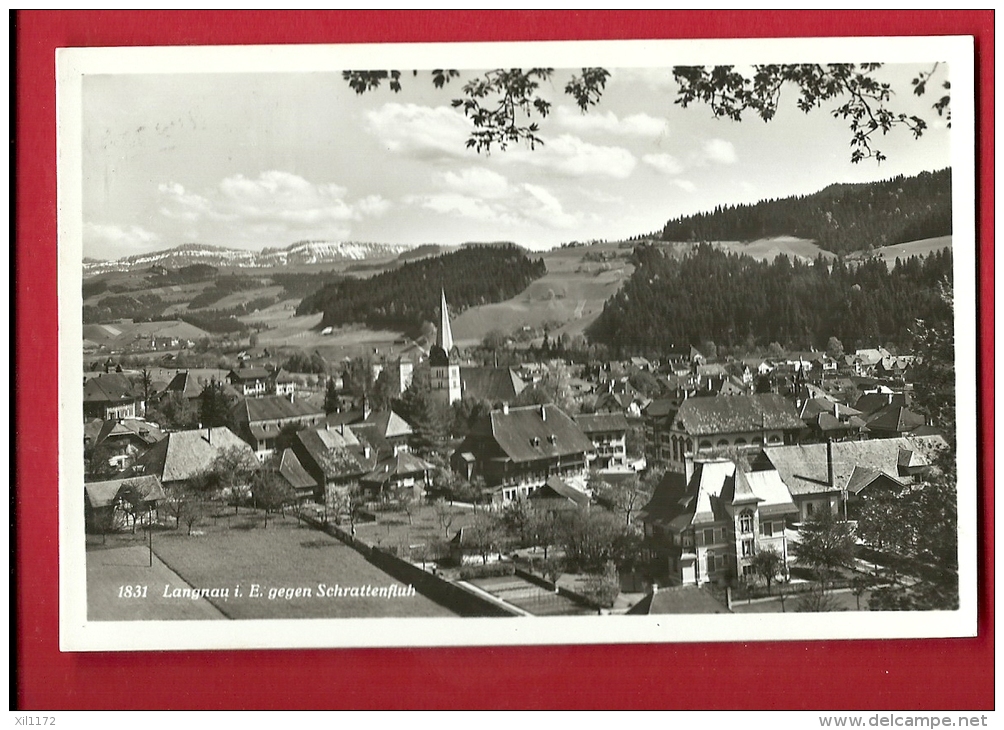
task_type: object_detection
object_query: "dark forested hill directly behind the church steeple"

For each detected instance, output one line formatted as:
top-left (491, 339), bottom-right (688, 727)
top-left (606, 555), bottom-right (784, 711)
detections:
top-left (296, 244), bottom-right (547, 330)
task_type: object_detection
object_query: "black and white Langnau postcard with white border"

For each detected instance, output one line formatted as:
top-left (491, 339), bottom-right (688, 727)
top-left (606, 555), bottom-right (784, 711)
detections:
top-left (57, 37), bottom-right (980, 651)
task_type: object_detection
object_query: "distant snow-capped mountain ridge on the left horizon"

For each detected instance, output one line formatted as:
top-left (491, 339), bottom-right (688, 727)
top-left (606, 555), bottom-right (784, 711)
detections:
top-left (83, 241), bottom-right (412, 275)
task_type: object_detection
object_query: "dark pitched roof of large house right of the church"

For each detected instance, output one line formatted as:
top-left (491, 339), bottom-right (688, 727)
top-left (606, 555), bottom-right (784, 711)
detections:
top-left (489, 404), bottom-right (592, 462)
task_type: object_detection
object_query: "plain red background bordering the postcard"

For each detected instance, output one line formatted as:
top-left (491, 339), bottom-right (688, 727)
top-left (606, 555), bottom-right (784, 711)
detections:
top-left (15, 11), bottom-right (994, 710)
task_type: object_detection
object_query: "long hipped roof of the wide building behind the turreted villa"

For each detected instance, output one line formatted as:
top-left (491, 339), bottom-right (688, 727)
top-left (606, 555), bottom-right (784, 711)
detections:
top-left (677, 393), bottom-right (804, 436)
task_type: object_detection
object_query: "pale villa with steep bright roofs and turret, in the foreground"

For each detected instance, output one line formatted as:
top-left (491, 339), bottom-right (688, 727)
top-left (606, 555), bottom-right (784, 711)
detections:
top-left (640, 457), bottom-right (797, 585)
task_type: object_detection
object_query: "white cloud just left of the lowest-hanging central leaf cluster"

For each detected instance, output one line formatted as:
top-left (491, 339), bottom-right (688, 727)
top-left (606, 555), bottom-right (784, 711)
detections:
top-left (365, 102), bottom-right (471, 159)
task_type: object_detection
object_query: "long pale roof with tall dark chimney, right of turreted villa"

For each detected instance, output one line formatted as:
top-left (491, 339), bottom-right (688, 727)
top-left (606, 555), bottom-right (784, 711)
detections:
top-left (763, 436), bottom-right (947, 496)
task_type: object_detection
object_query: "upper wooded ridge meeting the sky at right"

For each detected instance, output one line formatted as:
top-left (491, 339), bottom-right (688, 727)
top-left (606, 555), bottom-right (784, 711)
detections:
top-left (662, 168), bottom-right (952, 254)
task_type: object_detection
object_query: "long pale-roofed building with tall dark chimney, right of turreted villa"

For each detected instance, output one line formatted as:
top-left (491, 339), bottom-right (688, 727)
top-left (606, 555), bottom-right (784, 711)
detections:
top-left (763, 435), bottom-right (947, 521)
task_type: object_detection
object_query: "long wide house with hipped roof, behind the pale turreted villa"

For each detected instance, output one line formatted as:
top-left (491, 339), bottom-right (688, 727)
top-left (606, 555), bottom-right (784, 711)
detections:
top-left (660, 393), bottom-right (805, 471)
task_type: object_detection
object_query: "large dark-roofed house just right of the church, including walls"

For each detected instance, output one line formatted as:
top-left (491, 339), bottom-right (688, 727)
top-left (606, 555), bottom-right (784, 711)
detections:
top-left (451, 404), bottom-right (592, 502)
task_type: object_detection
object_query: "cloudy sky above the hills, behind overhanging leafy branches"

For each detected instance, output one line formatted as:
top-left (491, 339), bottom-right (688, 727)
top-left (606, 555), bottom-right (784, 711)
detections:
top-left (81, 63), bottom-right (951, 259)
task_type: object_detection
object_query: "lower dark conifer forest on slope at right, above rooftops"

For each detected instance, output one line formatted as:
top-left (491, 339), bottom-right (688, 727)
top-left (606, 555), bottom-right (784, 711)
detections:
top-left (588, 244), bottom-right (952, 356)
